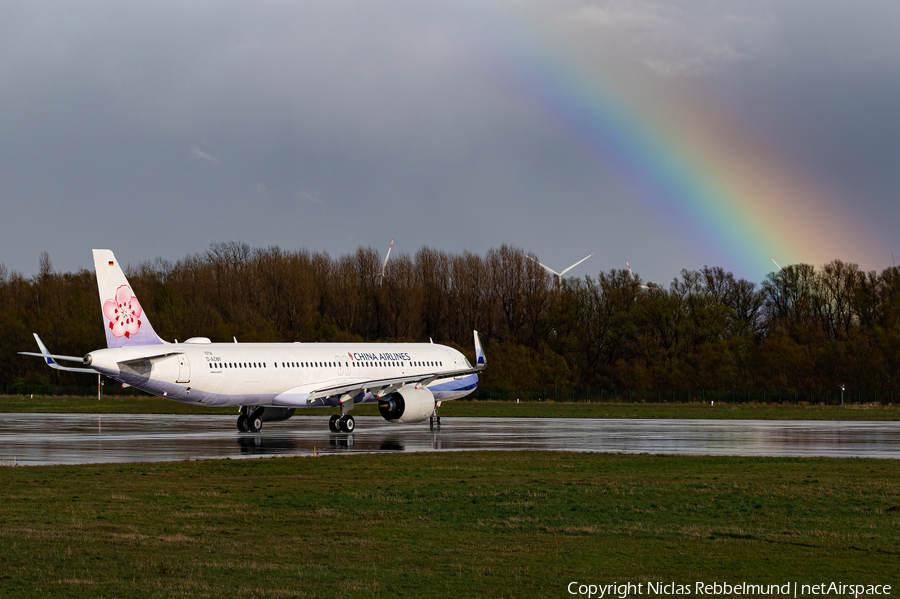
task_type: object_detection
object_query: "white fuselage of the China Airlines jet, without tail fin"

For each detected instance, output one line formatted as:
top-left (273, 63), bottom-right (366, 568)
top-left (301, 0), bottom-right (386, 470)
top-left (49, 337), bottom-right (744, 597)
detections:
top-left (88, 339), bottom-right (478, 408)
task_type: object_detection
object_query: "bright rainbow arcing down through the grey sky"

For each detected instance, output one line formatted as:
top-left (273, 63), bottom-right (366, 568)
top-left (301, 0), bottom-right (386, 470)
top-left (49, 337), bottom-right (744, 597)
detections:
top-left (464, 5), bottom-right (873, 281)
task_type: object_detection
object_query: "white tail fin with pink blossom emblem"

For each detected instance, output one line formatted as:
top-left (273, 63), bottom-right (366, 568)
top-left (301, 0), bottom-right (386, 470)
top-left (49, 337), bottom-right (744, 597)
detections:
top-left (94, 250), bottom-right (165, 347)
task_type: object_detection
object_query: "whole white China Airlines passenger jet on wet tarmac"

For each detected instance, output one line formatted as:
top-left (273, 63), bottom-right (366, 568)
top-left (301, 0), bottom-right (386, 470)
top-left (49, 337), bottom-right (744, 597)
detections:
top-left (19, 250), bottom-right (487, 433)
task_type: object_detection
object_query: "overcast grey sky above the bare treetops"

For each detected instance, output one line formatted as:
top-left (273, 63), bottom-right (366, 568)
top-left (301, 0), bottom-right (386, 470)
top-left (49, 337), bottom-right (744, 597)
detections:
top-left (0, 0), bottom-right (900, 283)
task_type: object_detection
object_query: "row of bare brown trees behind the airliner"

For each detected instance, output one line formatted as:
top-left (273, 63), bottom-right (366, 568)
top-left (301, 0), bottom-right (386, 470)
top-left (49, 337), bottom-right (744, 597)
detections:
top-left (0, 242), bottom-right (900, 390)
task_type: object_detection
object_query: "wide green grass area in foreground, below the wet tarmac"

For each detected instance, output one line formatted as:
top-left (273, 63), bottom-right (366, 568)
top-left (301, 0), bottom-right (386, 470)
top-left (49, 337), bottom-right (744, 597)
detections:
top-left (0, 452), bottom-right (900, 597)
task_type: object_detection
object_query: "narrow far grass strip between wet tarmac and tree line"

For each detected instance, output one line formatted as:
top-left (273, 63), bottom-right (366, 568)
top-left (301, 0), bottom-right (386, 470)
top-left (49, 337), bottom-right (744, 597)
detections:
top-left (0, 396), bottom-right (900, 420)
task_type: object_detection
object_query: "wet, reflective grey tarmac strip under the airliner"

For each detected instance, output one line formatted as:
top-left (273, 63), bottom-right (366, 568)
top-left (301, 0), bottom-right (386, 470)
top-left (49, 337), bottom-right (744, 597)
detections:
top-left (0, 414), bottom-right (900, 465)
